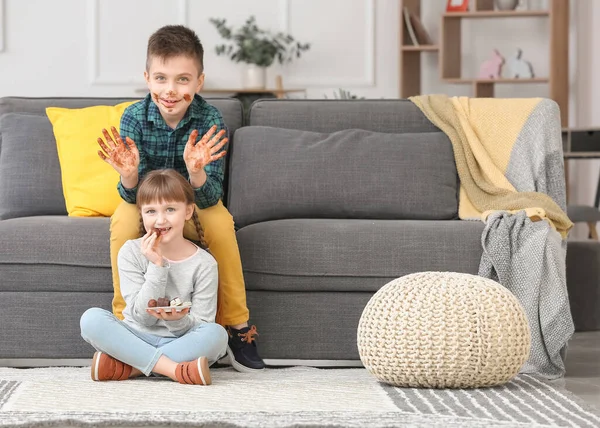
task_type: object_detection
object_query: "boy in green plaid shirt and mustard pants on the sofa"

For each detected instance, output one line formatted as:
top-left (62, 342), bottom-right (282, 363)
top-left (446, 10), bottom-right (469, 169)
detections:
top-left (98, 25), bottom-right (265, 372)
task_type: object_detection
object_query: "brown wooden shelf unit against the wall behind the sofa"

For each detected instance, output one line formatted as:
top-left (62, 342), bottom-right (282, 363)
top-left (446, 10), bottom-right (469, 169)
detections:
top-left (400, 0), bottom-right (569, 126)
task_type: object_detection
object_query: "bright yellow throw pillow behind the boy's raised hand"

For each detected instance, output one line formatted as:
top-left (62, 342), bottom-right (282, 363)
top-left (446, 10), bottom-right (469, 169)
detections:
top-left (46, 101), bottom-right (137, 217)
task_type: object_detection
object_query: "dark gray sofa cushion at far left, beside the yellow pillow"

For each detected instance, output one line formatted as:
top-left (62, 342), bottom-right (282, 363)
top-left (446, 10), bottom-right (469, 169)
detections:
top-left (0, 113), bottom-right (67, 219)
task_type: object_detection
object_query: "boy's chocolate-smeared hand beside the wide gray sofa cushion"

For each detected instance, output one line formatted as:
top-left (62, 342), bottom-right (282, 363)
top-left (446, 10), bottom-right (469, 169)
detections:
top-left (183, 125), bottom-right (228, 175)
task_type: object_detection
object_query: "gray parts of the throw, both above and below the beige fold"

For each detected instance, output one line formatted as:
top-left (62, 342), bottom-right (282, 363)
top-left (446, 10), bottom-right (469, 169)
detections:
top-left (479, 100), bottom-right (575, 379)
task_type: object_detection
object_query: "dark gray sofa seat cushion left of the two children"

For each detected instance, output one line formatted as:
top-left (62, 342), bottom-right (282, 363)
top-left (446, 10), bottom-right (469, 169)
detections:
top-left (0, 216), bottom-right (112, 292)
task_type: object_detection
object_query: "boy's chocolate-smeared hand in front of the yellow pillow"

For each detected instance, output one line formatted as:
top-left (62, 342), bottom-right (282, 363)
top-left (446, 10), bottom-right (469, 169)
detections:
top-left (98, 126), bottom-right (140, 178)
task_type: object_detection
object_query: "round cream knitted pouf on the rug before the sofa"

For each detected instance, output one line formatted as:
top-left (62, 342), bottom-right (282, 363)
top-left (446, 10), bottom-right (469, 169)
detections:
top-left (357, 272), bottom-right (531, 388)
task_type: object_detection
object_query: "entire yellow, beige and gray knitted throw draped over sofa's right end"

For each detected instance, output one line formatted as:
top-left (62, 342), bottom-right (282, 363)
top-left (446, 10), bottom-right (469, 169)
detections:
top-left (411, 95), bottom-right (574, 379)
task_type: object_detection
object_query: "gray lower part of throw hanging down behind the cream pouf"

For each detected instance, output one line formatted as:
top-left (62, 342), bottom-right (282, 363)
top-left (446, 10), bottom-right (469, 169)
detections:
top-left (479, 211), bottom-right (574, 379)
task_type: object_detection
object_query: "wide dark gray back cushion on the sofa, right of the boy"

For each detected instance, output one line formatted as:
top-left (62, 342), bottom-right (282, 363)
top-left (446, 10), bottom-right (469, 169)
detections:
top-left (228, 126), bottom-right (458, 227)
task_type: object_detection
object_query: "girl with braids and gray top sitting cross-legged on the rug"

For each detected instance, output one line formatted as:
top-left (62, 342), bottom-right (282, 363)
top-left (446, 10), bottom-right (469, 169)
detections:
top-left (80, 169), bottom-right (228, 385)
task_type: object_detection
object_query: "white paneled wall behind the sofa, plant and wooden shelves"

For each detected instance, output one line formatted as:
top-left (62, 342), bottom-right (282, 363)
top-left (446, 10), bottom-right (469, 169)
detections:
top-left (0, 0), bottom-right (600, 237)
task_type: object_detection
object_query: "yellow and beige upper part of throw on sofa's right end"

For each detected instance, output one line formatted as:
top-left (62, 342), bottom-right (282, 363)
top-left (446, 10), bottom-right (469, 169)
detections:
top-left (410, 95), bottom-right (573, 238)
